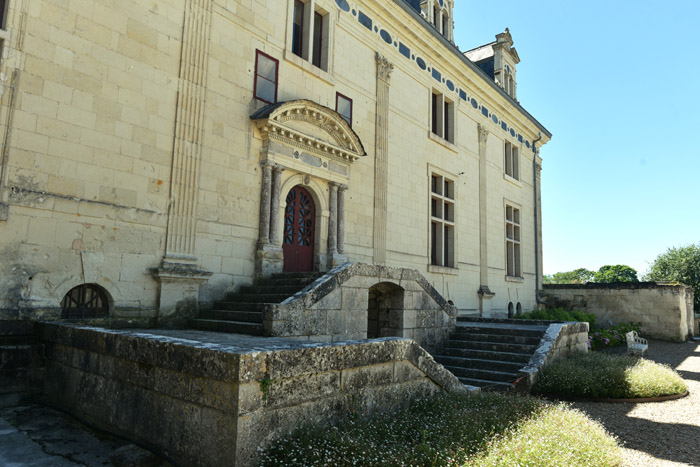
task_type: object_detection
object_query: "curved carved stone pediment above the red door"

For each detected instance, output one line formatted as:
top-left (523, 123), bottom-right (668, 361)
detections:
top-left (250, 100), bottom-right (367, 162)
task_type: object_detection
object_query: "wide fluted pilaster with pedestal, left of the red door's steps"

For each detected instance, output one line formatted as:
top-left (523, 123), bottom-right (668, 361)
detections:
top-left (152, 0), bottom-right (212, 325)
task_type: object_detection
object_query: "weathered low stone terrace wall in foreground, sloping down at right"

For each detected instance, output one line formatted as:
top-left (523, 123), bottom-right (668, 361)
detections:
top-left (40, 323), bottom-right (464, 467)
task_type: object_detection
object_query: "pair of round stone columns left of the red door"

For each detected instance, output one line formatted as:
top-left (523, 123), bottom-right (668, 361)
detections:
top-left (255, 161), bottom-right (284, 278)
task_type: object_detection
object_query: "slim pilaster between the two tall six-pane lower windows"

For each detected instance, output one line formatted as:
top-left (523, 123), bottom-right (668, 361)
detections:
top-left (477, 125), bottom-right (495, 316)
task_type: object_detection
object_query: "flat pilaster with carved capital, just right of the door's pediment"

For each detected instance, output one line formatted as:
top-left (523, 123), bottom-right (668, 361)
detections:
top-left (373, 53), bottom-right (394, 265)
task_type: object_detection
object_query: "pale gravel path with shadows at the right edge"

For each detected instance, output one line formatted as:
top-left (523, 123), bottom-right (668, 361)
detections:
top-left (573, 341), bottom-right (700, 467)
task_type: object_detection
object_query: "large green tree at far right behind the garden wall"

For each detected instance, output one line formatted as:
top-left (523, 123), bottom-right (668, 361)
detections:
top-left (644, 244), bottom-right (700, 312)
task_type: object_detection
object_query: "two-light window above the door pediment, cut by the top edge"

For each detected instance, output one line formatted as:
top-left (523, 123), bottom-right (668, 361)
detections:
top-left (290, 0), bottom-right (329, 71)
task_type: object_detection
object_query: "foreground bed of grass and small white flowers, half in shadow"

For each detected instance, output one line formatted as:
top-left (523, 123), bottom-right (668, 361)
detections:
top-left (261, 393), bottom-right (620, 467)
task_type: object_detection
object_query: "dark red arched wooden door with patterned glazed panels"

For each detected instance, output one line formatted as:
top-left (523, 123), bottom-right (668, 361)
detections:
top-left (282, 185), bottom-right (316, 272)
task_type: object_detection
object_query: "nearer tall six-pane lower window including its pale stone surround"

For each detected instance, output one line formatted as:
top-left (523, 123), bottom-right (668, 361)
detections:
top-left (427, 169), bottom-right (459, 274)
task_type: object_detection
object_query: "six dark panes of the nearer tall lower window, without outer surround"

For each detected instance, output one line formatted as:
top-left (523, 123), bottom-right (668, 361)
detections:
top-left (430, 173), bottom-right (455, 268)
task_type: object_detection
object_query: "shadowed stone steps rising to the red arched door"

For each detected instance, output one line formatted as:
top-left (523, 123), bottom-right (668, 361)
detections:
top-left (190, 272), bottom-right (320, 336)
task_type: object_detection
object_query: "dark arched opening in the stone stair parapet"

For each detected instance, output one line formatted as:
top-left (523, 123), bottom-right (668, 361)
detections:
top-left (367, 282), bottom-right (404, 339)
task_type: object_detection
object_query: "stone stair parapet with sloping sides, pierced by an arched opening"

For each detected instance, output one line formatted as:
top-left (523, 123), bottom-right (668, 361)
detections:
top-left (264, 263), bottom-right (457, 350)
